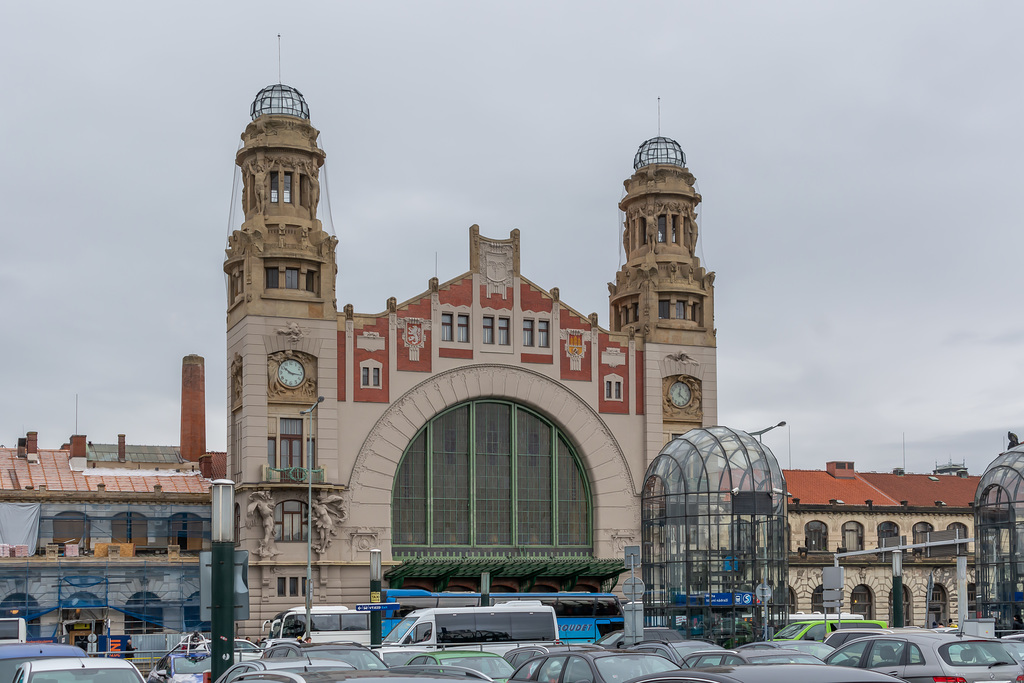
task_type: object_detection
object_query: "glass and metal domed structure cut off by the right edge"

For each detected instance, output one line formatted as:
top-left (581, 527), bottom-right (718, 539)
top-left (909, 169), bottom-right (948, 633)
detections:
top-left (974, 445), bottom-right (1024, 630)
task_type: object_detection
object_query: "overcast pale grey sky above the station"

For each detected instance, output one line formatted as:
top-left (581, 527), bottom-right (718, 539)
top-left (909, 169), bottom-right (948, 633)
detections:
top-left (0, 1), bottom-right (1024, 473)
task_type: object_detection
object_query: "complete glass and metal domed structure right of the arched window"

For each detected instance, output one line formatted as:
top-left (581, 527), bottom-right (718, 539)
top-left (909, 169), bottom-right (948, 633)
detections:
top-left (641, 427), bottom-right (788, 645)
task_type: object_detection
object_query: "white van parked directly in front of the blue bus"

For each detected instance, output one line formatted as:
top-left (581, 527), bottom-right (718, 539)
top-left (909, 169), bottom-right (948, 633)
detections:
top-left (383, 600), bottom-right (558, 654)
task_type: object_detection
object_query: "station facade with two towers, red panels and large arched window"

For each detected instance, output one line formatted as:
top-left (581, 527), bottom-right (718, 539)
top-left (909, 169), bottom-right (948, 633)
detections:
top-left (224, 85), bottom-right (718, 634)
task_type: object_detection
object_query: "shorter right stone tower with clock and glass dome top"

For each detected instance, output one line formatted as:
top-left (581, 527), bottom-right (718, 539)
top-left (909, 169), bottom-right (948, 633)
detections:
top-left (608, 137), bottom-right (717, 436)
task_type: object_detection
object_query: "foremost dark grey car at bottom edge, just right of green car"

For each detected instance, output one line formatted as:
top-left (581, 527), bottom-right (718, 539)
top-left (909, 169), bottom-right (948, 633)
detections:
top-left (509, 650), bottom-right (679, 683)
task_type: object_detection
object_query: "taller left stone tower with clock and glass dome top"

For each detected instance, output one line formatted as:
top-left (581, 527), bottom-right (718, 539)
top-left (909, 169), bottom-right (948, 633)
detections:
top-left (224, 84), bottom-right (338, 561)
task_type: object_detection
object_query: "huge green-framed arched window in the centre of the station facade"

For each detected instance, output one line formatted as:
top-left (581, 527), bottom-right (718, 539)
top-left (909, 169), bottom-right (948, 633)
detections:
top-left (391, 400), bottom-right (591, 550)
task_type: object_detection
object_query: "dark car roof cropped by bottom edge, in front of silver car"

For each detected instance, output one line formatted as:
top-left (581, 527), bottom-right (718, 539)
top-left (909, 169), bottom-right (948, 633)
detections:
top-left (630, 664), bottom-right (917, 683)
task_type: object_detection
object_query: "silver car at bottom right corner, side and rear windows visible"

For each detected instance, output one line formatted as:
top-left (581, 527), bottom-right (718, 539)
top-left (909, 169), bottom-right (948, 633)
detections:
top-left (825, 631), bottom-right (1024, 683)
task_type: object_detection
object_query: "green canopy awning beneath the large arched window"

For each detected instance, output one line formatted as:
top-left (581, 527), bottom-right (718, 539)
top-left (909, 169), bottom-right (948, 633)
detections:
top-left (384, 555), bottom-right (627, 591)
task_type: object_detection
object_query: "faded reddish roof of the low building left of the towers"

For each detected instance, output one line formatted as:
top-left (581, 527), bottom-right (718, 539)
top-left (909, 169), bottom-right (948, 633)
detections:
top-left (0, 449), bottom-right (210, 494)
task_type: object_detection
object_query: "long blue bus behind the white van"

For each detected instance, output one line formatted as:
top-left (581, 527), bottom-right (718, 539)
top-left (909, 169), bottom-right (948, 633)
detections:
top-left (381, 589), bottom-right (623, 643)
